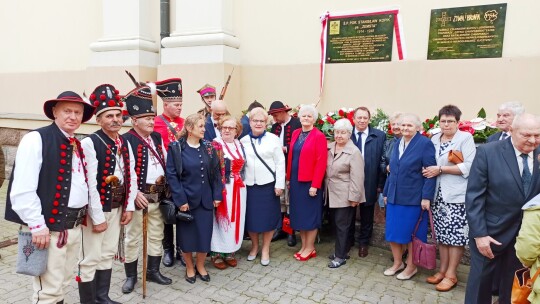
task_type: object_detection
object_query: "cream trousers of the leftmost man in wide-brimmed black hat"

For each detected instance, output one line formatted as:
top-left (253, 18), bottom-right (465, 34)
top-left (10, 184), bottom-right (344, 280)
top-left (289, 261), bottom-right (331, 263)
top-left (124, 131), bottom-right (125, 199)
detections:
top-left (23, 226), bottom-right (81, 304)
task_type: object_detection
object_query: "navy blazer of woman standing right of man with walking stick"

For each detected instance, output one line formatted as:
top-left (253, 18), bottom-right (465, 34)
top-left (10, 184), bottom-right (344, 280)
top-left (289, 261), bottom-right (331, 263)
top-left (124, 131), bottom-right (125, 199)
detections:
top-left (166, 138), bottom-right (223, 210)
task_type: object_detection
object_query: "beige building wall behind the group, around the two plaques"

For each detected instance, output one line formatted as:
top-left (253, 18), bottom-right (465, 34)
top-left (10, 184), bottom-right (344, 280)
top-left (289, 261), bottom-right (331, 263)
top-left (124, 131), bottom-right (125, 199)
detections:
top-left (0, 0), bottom-right (540, 127)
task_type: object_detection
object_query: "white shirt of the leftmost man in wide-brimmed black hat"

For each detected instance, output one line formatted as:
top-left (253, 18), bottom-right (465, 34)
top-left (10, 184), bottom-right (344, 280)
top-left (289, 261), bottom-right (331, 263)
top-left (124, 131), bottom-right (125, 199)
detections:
top-left (10, 130), bottom-right (90, 232)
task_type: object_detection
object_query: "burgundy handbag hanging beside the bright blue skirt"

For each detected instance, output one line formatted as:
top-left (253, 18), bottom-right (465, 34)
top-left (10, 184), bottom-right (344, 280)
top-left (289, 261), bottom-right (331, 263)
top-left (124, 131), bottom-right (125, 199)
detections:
top-left (412, 210), bottom-right (437, 270)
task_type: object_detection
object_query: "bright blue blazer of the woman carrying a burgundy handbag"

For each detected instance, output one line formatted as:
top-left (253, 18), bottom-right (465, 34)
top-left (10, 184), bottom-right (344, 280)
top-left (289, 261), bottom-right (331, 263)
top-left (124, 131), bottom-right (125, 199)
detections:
top-left (383, 133), bottom-right (437, 206)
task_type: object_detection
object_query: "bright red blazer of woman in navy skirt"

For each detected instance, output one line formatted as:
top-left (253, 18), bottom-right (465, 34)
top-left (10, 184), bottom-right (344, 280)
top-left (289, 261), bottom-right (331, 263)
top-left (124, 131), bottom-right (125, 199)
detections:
top-left (287, 128), bottom-right (328, 189)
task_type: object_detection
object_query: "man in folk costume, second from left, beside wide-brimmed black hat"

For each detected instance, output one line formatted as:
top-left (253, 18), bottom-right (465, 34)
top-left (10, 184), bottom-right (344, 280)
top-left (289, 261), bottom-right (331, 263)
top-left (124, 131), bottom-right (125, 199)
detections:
top-left (79, 84), bottom-right (137, 303)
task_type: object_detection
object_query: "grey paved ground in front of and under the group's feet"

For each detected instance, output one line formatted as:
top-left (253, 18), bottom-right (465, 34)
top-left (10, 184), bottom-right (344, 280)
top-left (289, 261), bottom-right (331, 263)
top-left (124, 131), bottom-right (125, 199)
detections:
top-left (0, 185), bottom-right (469, 304)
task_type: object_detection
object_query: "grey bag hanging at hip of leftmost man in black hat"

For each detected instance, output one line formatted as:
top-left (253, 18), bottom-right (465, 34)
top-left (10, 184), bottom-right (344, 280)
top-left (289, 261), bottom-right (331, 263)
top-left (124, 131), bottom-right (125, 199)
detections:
top-left (15, 226), bottom-right (49, 277)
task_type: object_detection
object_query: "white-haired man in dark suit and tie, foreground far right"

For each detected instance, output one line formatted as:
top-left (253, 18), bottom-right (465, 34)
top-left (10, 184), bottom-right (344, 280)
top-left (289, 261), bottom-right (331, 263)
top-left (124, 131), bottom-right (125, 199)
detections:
top-left (465, 114), bottom-right (540, 304)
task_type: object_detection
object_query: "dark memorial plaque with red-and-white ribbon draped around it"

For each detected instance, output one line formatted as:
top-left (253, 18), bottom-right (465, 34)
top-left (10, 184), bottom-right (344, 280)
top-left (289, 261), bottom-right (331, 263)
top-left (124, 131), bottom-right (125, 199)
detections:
top-left (326, 14), bottom-right (395, 63)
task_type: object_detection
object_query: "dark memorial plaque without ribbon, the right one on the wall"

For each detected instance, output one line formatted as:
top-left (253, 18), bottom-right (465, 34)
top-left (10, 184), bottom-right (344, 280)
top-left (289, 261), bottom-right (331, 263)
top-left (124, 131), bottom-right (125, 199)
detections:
top-left (428, 3), bottom-right (506, 59)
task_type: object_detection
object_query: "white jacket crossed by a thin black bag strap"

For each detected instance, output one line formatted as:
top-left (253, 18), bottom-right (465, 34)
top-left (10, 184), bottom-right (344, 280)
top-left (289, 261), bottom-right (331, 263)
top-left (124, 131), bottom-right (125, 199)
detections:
top-left (240, 132), bottom-right (285, 189)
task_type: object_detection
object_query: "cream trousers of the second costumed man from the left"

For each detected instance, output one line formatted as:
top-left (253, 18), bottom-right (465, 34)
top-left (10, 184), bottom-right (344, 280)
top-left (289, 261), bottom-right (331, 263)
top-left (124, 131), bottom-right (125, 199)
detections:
top-left (79, 207), bottom-right (122, 282)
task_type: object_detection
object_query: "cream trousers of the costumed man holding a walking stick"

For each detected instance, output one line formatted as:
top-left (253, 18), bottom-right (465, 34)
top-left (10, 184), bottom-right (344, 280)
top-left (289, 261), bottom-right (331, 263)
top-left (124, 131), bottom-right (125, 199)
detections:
top-left (126, 195), bottom-right (164, 263)
